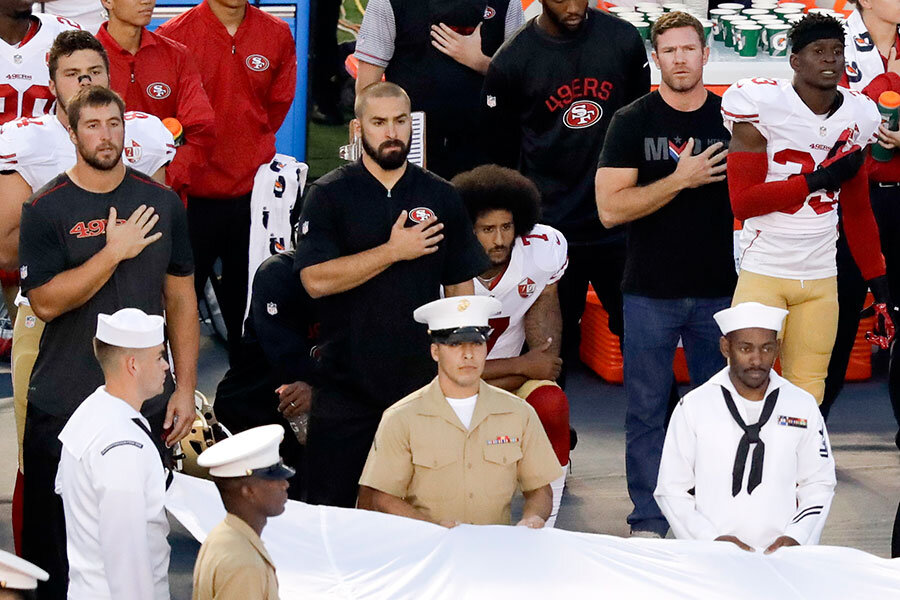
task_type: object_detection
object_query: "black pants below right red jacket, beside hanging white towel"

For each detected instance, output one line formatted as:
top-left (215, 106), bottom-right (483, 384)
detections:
top-left (187, 194), bottom-right (250, 363)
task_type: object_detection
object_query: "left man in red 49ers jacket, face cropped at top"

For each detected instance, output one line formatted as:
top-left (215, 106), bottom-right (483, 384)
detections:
top-left (97, 0), bottom-right (215, 197)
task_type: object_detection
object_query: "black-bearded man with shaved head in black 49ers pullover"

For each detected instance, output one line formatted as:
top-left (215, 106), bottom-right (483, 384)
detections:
top-left (294, 82), bottom-right (490, 507)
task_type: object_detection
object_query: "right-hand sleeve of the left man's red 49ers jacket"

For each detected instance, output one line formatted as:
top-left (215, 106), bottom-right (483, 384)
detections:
top-left (166, 55), bottom-right (216, 193)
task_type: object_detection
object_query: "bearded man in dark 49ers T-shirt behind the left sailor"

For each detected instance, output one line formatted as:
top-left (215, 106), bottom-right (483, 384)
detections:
top-left (19, 86), bottom-right (199, 598)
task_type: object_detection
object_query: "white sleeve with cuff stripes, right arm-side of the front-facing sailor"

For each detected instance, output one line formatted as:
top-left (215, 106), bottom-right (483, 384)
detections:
top-left (784, 410), bottom-right (836, 544)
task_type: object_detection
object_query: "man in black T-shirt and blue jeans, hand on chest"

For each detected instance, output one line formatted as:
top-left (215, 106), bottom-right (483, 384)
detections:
top-left (596, 12), bottom-right (737, 537)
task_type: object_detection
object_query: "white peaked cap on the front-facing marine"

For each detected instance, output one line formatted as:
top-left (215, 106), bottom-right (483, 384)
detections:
top-left (413, 296), bottom-right (503, 344)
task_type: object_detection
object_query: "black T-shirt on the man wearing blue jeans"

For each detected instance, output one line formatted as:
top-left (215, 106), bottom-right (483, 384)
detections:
top-left (600, 92), bottom-right (737, 298)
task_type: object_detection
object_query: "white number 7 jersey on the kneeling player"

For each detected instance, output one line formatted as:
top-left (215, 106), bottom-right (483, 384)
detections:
top-left (475, 225), bottom-right (569, 359)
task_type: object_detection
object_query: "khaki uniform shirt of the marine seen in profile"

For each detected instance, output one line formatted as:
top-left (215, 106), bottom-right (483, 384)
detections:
top-left (192, 514), bottom-right (278, 600)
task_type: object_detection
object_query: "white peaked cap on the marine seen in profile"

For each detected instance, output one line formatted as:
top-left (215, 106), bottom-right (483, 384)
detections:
top-left (197, 425), bottom-right (294, 479)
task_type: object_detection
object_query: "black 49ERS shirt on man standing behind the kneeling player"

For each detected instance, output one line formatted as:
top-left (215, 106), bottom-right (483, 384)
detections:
top-left (482, 9), bottom-right (650, 245)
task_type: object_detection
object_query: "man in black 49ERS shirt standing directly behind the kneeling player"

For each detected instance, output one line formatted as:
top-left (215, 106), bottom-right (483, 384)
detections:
top-left (482, 0), bottom-right (650, 384)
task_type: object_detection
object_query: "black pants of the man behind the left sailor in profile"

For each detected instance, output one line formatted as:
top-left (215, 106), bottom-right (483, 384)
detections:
top-left (22, 402), bottom-right (165, 600)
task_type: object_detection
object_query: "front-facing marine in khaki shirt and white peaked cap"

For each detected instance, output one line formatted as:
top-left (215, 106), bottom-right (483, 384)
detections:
top-left (358, 296), bottom-right (562, 528)
